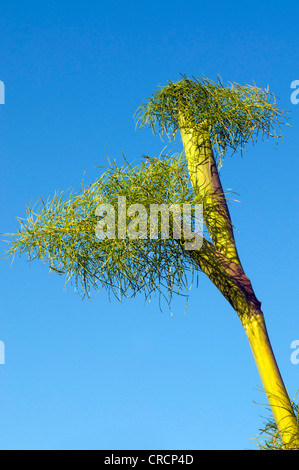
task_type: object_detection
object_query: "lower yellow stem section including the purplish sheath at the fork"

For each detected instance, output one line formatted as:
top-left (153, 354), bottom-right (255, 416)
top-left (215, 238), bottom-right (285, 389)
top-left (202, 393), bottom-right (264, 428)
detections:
top-left (188, 239), bottom-right (299, 449)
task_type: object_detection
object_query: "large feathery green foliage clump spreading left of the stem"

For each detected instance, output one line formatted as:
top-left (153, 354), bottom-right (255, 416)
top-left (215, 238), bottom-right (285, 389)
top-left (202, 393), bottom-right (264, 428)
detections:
top-left (2, 154), bottom-right (199, 302)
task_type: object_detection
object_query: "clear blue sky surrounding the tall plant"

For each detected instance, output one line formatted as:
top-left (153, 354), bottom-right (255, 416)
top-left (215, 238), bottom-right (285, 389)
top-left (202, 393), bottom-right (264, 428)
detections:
top-left (0, 0), bottom-right (299, 450)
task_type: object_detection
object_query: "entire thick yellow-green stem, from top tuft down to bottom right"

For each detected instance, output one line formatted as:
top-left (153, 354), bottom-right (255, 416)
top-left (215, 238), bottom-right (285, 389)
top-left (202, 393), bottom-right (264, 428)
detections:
top-left (180, 117), bottom-right (299, 449)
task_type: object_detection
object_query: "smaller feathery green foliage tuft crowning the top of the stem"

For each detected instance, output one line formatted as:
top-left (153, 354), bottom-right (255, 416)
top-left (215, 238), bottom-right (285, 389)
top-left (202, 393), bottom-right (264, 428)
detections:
top-left (135, 77), bottom-right (286, 165)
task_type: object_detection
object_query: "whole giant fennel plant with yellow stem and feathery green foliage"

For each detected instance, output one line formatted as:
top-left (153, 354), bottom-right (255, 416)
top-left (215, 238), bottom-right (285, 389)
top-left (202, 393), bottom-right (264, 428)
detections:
top-left (2, 76), bottom-right (299, 449)
